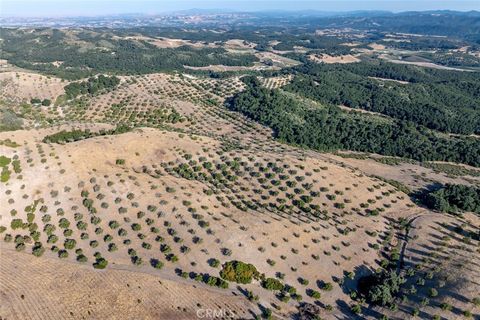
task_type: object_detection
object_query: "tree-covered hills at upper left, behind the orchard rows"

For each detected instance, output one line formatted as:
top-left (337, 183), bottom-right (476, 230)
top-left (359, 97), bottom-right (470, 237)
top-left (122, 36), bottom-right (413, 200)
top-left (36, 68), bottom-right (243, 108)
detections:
top-left (0, 29), bottom-right (258, 79)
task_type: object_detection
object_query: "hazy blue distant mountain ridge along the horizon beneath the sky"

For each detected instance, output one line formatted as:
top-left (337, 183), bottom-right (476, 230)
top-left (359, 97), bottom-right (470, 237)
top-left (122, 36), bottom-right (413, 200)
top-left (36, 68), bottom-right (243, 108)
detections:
top-left (0, 9), bottom-right (480, 43)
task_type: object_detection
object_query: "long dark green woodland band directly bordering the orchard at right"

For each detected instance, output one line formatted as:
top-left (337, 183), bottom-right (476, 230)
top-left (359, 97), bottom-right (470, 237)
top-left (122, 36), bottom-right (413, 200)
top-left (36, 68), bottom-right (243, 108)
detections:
top-left (227, 77), bottom-right (480, 166)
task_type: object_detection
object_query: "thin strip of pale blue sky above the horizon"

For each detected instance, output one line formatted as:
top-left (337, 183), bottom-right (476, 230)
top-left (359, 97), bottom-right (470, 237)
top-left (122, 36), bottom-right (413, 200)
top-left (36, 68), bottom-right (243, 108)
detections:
top-left (0, 0), bottom-right (480, 17)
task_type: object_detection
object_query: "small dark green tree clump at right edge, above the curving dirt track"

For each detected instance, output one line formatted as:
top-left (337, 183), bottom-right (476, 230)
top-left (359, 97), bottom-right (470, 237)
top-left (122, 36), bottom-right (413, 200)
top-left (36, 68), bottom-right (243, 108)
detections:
top-left (424, 184), bottom-right (480, 214)
